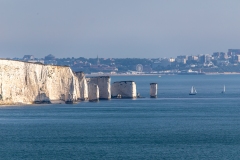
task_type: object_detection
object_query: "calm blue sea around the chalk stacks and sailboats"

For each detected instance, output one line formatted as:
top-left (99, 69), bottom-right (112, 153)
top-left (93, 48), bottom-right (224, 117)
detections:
top-left (0, 75), bottom-right (240, 160)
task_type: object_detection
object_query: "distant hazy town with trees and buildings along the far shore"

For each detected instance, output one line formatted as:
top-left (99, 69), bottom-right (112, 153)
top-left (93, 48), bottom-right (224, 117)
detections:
top-left (7, 49), bottom-right (240, 75)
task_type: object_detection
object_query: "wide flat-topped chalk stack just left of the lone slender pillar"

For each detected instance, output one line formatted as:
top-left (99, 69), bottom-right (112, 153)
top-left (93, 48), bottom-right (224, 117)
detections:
top-left (111, 81), bottom-right (137, 98)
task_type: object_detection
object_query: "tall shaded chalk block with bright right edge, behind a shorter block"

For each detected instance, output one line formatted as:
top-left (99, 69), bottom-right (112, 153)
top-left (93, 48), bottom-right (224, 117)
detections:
top-left (88, 76), bottom-right (111, 99)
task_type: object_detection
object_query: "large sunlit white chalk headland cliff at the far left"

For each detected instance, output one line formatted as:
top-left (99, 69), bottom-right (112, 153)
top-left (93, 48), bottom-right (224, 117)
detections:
top-left (0, 59), bottom-right (84, 105)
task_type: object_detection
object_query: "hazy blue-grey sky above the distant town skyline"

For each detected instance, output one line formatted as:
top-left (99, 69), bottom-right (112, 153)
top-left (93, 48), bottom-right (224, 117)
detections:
top-left (0, 0), bottom-right (240, 58)
